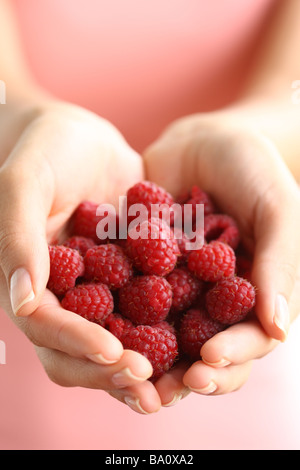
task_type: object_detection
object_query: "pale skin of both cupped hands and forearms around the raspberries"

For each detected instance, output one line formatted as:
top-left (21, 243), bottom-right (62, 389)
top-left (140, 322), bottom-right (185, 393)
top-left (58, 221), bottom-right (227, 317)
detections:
top-left (0, 0), bottom-right (300, 414)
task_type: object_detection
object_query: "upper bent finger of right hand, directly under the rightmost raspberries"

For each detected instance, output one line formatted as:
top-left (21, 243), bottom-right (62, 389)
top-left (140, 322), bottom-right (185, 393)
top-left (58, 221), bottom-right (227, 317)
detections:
top-left (200, 319), bottom-right (279, 368)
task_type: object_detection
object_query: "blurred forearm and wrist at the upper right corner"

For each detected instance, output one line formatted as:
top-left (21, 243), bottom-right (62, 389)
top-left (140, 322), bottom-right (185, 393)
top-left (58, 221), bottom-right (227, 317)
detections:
top-left (224, 0), bottom-right (300, 181)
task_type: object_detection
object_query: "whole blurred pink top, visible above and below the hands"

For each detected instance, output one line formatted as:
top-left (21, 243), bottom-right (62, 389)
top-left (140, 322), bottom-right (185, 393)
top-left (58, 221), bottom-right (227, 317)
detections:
top-left (0, 0), bottom-right (300, 450)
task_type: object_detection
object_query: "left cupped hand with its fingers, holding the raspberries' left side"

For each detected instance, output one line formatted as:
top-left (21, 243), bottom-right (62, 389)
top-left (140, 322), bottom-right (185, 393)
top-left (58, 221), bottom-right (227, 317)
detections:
top-left (0, 102), bottom-right (160, 411)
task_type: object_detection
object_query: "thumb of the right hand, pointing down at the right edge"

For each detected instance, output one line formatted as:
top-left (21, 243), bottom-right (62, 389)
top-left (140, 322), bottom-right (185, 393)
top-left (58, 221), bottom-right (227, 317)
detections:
top-left (251, 171), bottom-right (300, 341)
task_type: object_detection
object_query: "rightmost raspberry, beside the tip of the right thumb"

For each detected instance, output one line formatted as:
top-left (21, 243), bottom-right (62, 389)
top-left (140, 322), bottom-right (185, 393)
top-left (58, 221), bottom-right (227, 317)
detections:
top-left (206, 276), bottom-right (255, 325)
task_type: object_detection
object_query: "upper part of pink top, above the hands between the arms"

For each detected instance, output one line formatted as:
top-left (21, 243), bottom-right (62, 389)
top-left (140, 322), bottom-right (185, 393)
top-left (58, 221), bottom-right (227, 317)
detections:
top-left (12, 0), bottom-right (274, 151)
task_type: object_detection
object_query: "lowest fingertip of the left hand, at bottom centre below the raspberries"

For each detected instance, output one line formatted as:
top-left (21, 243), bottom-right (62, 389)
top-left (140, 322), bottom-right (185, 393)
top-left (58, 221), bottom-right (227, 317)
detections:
top-left (109, 380), bottom-right (161, 415)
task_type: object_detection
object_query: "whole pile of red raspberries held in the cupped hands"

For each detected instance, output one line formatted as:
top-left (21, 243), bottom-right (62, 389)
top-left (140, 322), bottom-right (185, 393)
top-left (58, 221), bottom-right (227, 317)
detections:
top-left (48, 181), bottom-right (255, 380)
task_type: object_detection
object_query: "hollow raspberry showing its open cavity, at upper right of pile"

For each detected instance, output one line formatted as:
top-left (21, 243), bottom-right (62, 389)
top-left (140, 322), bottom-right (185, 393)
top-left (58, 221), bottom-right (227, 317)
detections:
top-left (204, 214), bottom-right (240, 250)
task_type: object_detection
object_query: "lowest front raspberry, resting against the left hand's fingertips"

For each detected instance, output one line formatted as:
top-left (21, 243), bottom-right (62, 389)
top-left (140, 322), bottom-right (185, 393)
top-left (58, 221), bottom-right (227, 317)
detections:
top-left (122, 325), bottom-right (178, 379)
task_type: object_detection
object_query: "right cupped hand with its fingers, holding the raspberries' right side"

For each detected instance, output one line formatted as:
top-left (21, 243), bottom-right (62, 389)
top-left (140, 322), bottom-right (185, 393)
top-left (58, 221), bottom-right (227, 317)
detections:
top-left (144, 112), bottom-right (300, 404)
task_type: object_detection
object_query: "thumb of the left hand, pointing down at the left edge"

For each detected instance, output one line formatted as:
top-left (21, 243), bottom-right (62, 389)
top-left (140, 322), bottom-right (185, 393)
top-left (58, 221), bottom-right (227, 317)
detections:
top-left (0, 162), bottom-right (49, 316)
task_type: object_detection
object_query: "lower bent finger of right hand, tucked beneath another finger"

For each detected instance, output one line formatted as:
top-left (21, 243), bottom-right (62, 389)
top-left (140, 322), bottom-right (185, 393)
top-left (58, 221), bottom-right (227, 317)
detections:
top-left (183, 361), bottom-right (252, 395)
